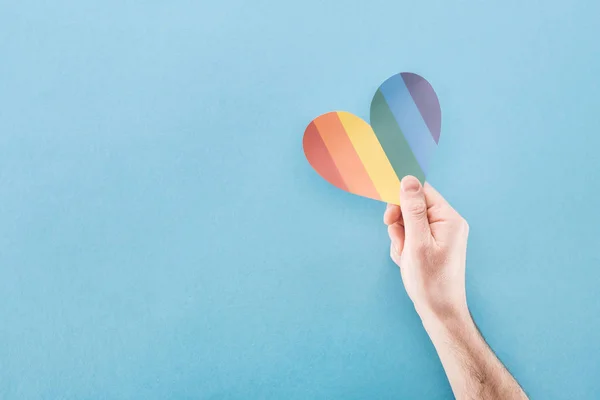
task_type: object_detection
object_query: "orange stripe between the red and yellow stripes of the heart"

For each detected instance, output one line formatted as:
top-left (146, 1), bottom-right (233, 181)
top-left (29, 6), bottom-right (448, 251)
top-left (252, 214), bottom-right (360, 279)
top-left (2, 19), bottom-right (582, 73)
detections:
top-left (314, 112), bottom-right (381, 200)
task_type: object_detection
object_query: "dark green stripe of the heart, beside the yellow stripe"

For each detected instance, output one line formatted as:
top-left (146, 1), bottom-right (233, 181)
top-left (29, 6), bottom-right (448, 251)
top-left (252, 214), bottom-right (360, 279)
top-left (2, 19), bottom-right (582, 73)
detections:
top-left (371, 89), bottom-right (425, 182)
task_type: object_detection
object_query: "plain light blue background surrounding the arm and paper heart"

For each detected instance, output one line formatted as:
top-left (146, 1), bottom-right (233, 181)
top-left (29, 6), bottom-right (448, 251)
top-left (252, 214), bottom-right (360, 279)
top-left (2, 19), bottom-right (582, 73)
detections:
top-left (0, 0), bottom-right (600, 400)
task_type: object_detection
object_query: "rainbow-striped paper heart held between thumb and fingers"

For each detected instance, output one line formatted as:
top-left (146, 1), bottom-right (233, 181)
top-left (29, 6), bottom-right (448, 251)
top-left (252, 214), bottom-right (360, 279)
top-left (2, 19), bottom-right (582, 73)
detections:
top-left (303, 72), bottom-right (442, 204)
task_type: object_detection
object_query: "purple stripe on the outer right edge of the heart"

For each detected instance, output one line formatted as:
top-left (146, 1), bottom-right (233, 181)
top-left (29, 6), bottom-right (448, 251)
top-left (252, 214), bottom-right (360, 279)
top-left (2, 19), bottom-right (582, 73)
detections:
top-left (400, 72), bottom-right (442, 143)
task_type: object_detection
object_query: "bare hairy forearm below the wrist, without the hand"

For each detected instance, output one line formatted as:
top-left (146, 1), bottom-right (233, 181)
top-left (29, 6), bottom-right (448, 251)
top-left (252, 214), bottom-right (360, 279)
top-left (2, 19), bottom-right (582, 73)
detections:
top-left (422, 308), bottom-right (527, 400)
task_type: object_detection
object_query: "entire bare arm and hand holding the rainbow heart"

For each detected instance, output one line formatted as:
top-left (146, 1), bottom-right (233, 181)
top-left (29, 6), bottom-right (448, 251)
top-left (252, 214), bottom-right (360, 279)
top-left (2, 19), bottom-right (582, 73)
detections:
top-left (384, 176), bottom-right (528, 400)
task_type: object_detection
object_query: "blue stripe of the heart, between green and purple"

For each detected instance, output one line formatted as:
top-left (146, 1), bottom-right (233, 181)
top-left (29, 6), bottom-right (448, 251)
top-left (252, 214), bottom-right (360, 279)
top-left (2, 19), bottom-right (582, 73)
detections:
top-left (379, 74), bottom-right (437, 175)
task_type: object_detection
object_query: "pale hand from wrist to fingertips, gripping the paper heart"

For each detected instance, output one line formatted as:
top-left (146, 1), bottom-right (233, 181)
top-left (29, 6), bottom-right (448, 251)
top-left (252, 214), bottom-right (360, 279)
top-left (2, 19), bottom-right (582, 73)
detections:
top-left (384, 176), bottom-right (469, 319)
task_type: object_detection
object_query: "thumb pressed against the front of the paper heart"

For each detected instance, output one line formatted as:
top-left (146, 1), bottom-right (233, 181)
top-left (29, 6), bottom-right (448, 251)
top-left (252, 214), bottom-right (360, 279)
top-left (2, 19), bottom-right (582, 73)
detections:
top-left (400, 175), bottom-right (431, 243)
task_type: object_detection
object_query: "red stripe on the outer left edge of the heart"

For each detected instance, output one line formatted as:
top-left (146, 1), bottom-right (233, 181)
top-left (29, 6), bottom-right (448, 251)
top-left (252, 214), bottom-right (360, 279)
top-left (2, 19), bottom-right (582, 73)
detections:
top-left (302, 121), bottom-right (348, 191)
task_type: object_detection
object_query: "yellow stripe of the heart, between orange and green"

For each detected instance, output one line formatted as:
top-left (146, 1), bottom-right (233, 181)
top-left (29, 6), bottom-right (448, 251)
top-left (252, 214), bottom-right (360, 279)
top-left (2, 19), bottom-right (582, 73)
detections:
top-left (338, 111), bottom-right (400, 204)
